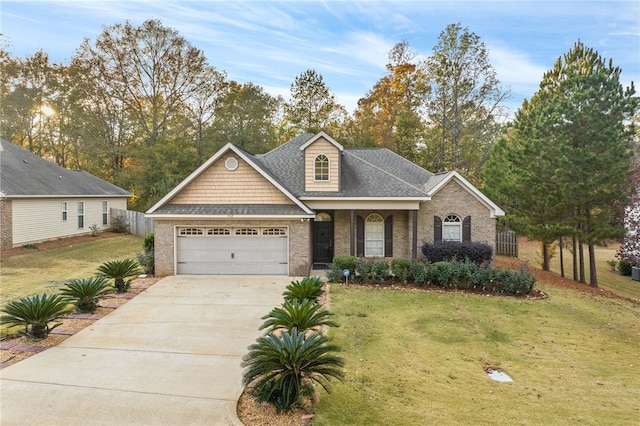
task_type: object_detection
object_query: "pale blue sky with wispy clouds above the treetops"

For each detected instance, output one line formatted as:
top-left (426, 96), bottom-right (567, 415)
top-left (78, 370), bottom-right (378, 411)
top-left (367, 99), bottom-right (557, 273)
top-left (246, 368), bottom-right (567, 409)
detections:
top-left (0, 0), bottom-right (640, 114)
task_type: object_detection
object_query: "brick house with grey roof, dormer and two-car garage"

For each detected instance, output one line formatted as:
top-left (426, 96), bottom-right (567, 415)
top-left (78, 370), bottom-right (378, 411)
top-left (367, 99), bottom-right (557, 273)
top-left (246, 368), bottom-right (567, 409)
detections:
top-left (147, 132), bottom-right (504, 276)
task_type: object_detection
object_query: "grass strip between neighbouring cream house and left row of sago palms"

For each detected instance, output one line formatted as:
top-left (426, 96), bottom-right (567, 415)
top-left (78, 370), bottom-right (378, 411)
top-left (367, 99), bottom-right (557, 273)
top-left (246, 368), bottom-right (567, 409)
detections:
top-left (0, 235), bottom-right (143, 312)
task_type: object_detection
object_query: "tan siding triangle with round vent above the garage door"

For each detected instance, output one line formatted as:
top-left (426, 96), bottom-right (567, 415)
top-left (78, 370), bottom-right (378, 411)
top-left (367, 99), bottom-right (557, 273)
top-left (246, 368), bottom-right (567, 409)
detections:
top-left (169, 154), bottom-right (293, 204)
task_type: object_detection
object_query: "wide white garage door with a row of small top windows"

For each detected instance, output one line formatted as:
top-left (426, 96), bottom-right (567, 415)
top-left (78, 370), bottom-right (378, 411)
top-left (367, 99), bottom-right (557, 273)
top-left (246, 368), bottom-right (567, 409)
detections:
top-left (176, 227), bottom-right (289, 275)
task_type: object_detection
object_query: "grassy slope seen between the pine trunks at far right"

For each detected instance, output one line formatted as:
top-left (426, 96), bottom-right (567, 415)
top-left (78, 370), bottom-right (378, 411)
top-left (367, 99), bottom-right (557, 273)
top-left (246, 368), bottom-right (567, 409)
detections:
top-left (518, 238), bottom-right (640, 300)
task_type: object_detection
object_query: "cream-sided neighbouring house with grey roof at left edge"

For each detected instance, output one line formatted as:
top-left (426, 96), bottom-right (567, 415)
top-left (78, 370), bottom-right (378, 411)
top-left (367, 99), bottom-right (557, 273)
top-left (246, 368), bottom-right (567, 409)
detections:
top-left (0, 138), bottom-right (131, 250)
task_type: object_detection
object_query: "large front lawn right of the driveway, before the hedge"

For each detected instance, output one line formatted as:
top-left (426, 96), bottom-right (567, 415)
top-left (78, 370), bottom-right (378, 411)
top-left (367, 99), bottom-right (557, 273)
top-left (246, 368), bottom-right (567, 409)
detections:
top-left (314, 284), bottom-right (640, 426)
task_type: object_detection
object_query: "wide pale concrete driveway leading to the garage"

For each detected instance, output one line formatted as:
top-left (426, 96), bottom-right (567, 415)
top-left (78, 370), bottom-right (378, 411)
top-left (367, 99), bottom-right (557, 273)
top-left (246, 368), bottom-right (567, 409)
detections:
top-left (0, 276), bottom-right (292, 426)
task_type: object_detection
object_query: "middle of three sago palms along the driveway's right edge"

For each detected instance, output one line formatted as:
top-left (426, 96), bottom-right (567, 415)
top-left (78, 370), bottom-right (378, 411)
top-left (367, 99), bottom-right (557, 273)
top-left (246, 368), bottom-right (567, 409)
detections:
top-left (260, 299), bottom-right (338, 331)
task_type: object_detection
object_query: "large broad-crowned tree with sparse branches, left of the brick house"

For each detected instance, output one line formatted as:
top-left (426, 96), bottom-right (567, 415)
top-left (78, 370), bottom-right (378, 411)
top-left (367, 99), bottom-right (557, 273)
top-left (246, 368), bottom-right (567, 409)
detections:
top-left (76, 20), bottom-right (208, 146)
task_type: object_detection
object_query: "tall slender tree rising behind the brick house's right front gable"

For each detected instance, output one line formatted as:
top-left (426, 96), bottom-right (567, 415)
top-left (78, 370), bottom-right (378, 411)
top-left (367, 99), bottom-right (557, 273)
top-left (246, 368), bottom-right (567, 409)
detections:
top-left (424, 24), bottom-right (510, 181)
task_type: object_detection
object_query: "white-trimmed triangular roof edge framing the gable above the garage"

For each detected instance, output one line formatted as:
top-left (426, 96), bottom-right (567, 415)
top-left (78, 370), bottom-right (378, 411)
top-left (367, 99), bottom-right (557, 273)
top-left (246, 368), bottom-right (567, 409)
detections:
top-left (147, 143), bottom-right (313, 215)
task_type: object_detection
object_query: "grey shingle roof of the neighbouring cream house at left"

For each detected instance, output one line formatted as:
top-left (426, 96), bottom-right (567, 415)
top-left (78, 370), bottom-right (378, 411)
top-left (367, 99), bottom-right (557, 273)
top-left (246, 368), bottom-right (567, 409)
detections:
top-left (0, 138), bottom-right (131, 198)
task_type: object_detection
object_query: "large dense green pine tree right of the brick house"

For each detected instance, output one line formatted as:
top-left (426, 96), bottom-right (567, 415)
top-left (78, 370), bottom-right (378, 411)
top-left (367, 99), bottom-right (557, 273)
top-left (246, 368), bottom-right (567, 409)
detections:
top-left (486, 42), bottom-right (638, 286)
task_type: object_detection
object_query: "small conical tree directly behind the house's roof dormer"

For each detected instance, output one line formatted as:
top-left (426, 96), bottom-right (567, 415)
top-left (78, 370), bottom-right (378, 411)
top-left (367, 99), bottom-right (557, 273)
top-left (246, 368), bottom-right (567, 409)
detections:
top-left (284, 69), bottom-right (347, 138)
